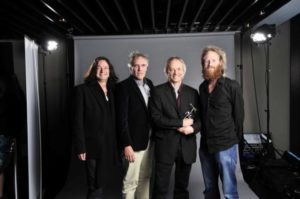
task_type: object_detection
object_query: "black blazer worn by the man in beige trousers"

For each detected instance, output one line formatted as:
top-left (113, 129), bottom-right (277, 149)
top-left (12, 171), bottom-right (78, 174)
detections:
top-left (116, 76), bottom-right (153, 151)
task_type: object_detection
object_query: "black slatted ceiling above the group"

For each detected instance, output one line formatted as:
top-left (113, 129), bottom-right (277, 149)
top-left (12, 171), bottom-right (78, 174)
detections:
top-left (0, 0), bottom-right (290, 41)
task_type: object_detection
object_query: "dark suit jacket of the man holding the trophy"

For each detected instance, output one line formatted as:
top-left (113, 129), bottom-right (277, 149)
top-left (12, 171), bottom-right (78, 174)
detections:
top-left (149, 82), bottom-right (200, 164)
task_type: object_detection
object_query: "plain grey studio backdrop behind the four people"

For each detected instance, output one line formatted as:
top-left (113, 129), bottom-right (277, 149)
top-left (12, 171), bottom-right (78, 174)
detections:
top-left (74, 32), bottom-right (236, 198)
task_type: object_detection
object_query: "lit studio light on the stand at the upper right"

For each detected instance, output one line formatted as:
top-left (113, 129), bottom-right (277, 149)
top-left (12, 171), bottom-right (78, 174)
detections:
top-left (250, 24), bottom-right (276, 44)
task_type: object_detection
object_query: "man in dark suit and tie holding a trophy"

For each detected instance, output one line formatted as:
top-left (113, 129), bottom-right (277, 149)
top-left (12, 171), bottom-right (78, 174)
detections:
top-left (150, 57), bottom-right (200, 199)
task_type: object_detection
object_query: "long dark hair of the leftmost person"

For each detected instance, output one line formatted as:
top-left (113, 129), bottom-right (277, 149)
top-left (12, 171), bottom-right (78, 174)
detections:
top-left (84, 57), bottom-right (119, 85)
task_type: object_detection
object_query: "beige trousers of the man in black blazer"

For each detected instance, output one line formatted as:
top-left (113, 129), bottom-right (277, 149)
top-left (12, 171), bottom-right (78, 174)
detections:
top-left (122, 144), bottom-right (153, 199)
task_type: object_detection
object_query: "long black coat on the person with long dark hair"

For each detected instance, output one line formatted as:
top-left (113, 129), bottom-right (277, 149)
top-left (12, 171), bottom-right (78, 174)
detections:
top-left (73, 81), bottom-right (117, 160)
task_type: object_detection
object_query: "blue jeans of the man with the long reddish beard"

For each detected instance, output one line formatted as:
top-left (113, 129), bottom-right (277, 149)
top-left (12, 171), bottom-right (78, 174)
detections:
top-left (199, 144), bottom-right (239, 199)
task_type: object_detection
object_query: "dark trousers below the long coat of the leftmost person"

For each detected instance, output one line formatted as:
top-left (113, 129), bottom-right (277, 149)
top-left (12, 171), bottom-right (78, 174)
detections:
top-left (86, 159), bottom-right (103, 199)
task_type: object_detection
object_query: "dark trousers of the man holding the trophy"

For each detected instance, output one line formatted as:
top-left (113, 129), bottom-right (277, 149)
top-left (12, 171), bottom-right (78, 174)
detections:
top-left (152, 145), bottom-right (192, 199)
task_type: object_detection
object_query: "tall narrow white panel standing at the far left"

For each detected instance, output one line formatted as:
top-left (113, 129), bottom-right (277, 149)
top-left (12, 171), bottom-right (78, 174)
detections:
top-left (24, 37), bottom-right (42, 199)
